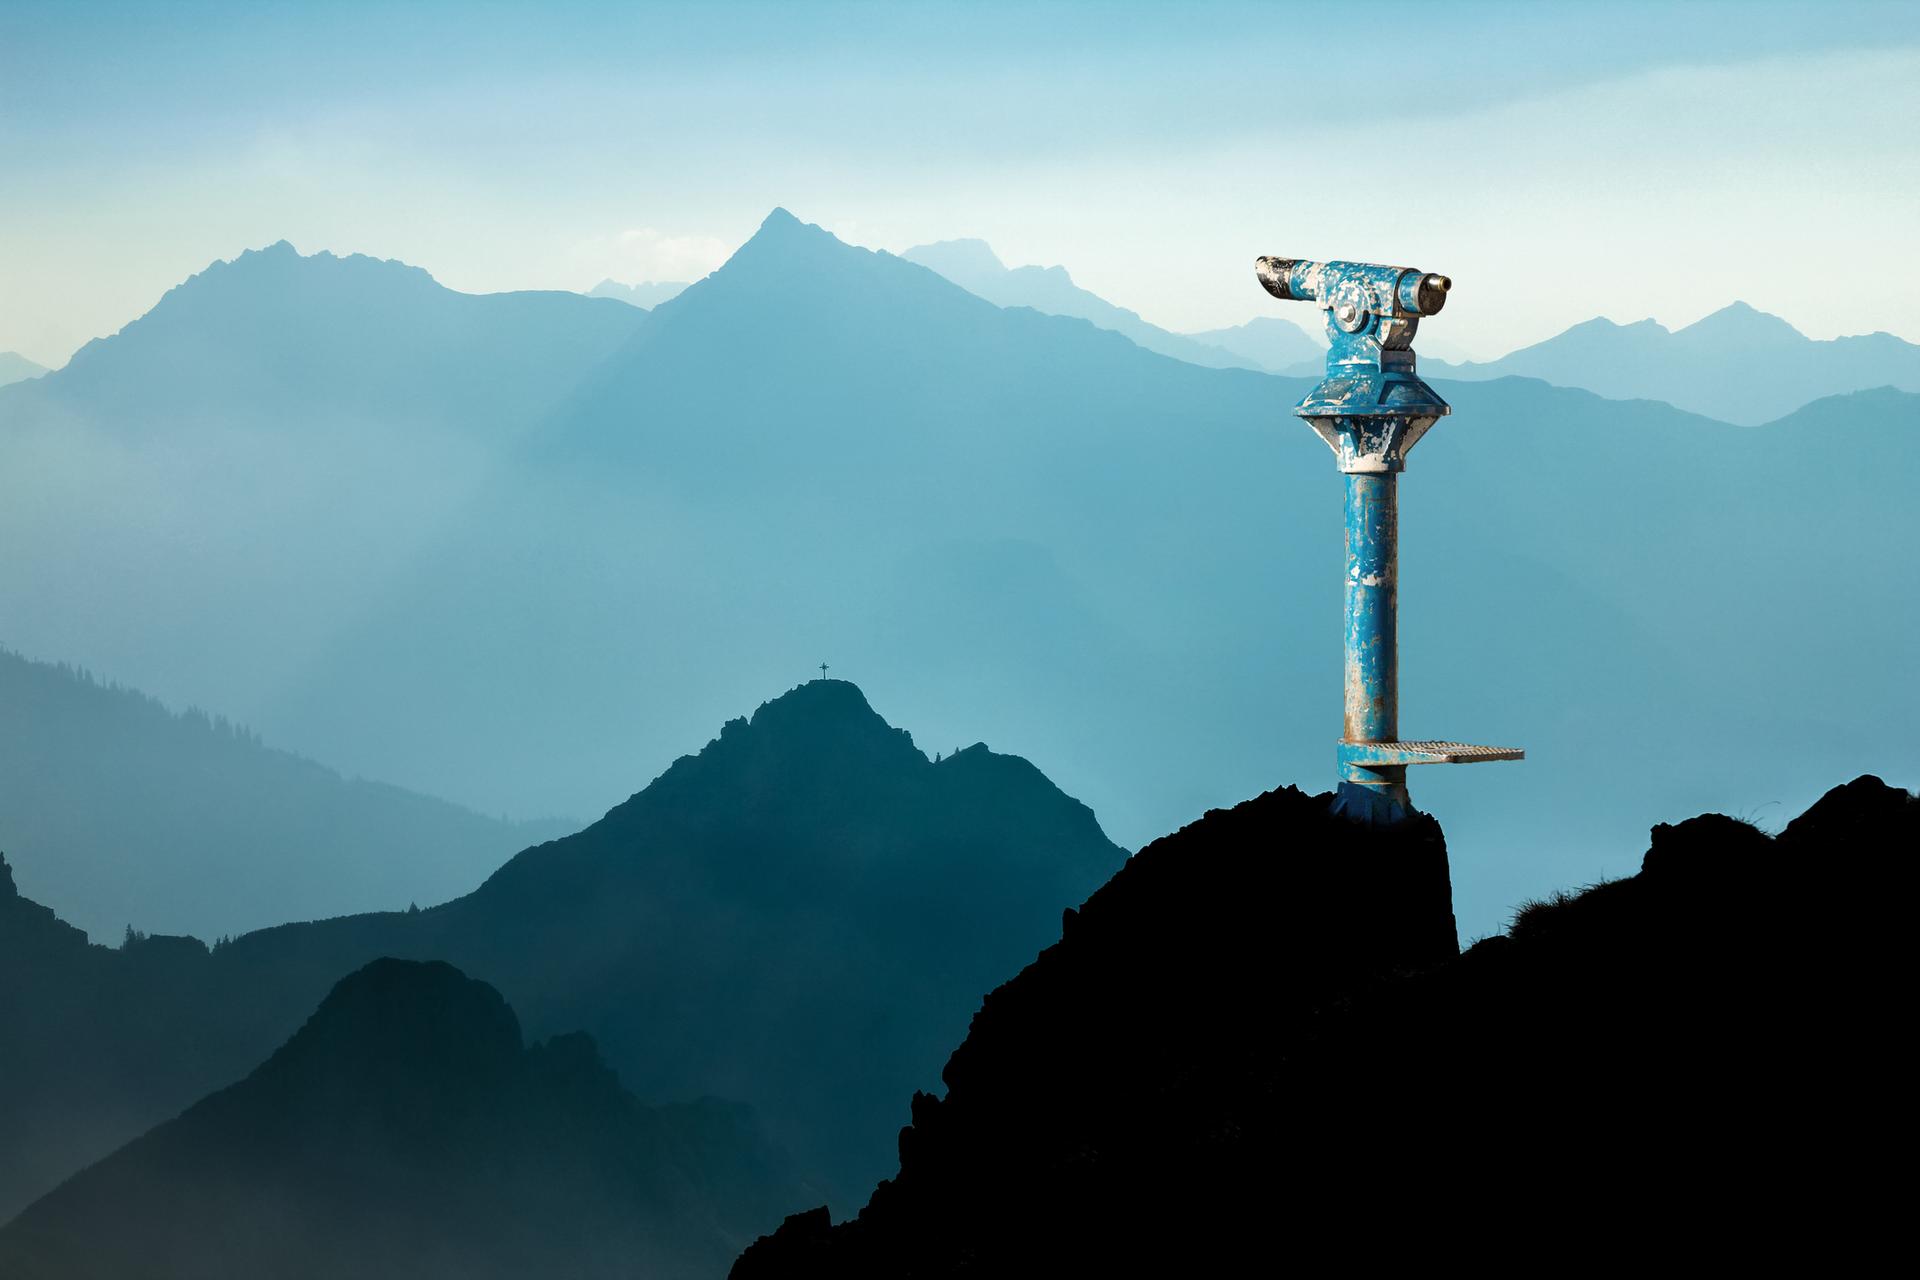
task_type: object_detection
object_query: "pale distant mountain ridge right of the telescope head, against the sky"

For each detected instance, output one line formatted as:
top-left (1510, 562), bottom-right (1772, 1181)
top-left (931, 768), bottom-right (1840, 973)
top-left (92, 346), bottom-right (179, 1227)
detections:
top-left (1427, 301), bottom-right (1920, 426)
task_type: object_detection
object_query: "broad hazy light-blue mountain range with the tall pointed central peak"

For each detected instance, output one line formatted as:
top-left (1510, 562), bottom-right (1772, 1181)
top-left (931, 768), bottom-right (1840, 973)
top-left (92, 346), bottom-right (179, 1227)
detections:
top-left (0, 213), bottom-right (1920, 948)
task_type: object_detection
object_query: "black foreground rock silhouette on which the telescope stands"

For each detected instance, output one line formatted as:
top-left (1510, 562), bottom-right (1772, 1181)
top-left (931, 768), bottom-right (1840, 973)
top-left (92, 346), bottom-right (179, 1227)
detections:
top-left (732, 777), bottom-right (1920, 1280)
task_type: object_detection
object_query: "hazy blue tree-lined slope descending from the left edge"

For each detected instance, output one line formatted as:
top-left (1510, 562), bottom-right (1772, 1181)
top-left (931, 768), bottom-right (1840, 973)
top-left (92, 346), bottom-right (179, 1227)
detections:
top-left (0, 651), bottom-right (572, 940)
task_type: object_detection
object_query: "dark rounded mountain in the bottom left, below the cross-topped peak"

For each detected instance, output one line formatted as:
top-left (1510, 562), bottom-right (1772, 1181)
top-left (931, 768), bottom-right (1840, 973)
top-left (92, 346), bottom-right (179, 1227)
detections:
top-left (0, 960), bottom-right (806, 1280)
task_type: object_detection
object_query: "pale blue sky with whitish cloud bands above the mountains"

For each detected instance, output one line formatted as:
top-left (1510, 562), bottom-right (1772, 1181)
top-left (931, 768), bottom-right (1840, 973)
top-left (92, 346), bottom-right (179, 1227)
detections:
top-left (0, 0), bottom-right (1920, 363)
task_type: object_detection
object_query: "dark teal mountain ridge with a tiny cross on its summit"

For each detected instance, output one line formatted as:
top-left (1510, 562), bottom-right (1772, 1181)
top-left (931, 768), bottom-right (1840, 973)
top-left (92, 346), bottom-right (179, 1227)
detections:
top-left (0, 679), bottom-right (1125, 1221)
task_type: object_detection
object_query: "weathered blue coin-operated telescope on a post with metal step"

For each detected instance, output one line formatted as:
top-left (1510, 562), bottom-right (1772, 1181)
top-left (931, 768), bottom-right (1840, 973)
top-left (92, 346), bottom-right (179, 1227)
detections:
top-left (1254, 257), bottom-right (1524, 821)
